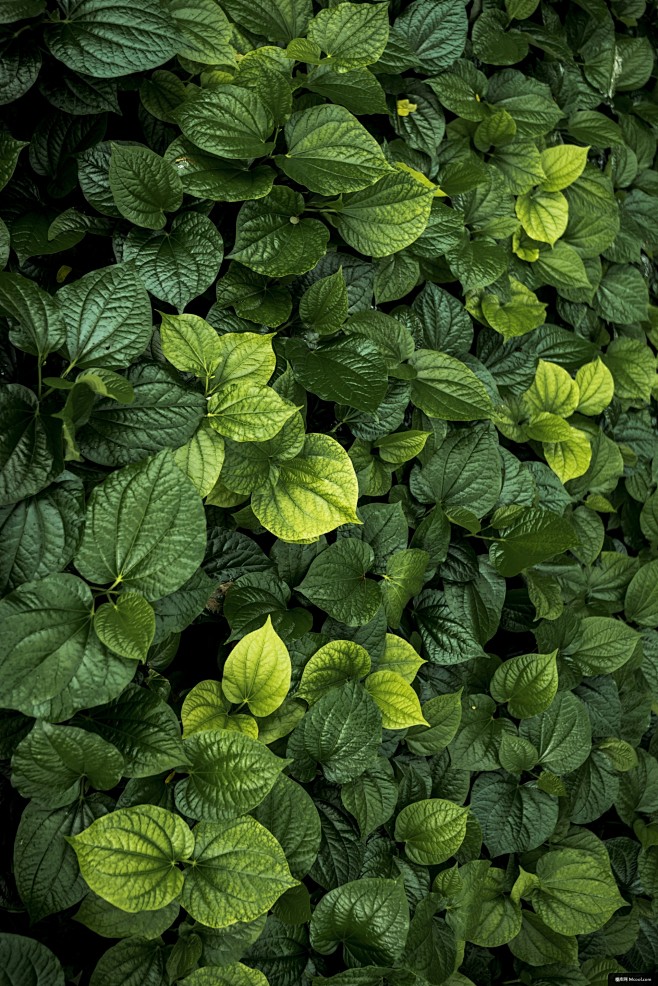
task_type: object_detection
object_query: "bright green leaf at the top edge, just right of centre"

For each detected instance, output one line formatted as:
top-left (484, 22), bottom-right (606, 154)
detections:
top-left (308, 3), bottom-right (388, 69)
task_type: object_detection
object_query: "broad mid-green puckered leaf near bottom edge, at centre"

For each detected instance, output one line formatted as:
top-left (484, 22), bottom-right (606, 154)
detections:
top-left (311, 878), bottom-right (409, 966)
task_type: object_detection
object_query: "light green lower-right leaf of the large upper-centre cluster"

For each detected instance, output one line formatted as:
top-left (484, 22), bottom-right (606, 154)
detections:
top-left (334, 173), bottom-right (432, 257)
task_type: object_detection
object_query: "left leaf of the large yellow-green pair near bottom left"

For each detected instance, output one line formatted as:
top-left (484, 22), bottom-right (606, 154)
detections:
top-left (68, 805), bottom-right (194, 914)
